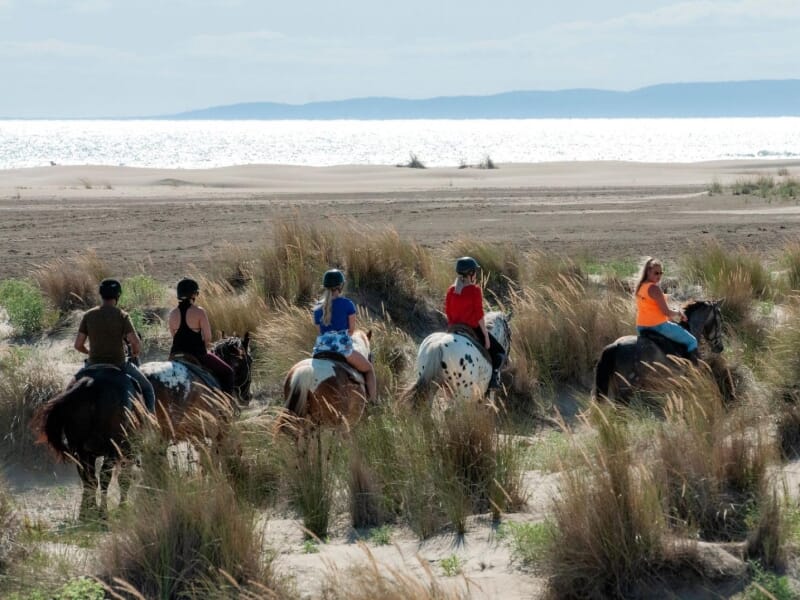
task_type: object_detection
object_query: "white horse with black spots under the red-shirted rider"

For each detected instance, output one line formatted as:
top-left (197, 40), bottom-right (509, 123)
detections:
top-left (404, 311), bottom-right (511, 404)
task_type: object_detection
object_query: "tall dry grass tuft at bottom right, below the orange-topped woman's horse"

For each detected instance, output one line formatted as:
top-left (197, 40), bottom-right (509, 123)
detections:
top-left (547, 405), bottom-right (688, 598)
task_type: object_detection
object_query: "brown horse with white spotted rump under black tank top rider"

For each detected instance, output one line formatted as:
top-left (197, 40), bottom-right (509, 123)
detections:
top-left (141, 333), bottom-right (253, 441)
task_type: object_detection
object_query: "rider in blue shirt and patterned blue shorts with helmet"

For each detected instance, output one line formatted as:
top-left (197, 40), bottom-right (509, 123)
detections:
top-left (313, 269), bottom-right (376, 402)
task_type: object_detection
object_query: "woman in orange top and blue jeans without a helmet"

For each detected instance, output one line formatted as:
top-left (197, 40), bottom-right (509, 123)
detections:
top-left (634, 257), bottom-right (697, 365)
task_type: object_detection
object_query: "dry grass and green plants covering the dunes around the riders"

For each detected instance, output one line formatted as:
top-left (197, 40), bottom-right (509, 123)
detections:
top-left (0, 220), bottom-right (800, 600)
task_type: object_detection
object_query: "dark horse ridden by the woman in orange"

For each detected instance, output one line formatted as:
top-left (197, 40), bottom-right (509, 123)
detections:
top-left (592, 300), bottom-right (724, 399)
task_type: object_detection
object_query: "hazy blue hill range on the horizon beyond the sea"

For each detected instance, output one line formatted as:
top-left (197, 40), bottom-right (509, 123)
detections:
top-left (164, 79), bottom-right (800, 119)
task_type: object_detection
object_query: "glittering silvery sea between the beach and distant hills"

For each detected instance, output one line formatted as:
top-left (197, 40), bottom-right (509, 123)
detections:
top-left (0, 117), bottom-right (800, 169)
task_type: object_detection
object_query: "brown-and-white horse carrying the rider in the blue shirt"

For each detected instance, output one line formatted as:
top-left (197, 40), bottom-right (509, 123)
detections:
top-left (283, 329), bottom-right (372, 428)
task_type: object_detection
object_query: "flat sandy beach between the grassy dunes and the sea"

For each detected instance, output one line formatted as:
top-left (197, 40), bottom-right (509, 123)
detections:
top-left (0, 160), bottom-right (800, 280)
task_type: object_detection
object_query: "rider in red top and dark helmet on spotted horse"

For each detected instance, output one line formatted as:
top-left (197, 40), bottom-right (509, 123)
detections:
top-left (444, 256), bottom-right (506, 389)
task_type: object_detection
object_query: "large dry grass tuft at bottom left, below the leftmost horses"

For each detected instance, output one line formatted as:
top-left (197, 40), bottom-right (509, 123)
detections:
top-left (99, 458), bottom-right (288, 600)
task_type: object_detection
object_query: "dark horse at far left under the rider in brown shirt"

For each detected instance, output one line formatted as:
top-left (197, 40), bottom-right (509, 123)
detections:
top-left (32, 365), bottom-right (143, 519)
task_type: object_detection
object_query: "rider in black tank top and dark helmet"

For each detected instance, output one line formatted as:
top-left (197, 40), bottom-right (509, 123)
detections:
top-left (167, 278), bottom-right (234, 395)
